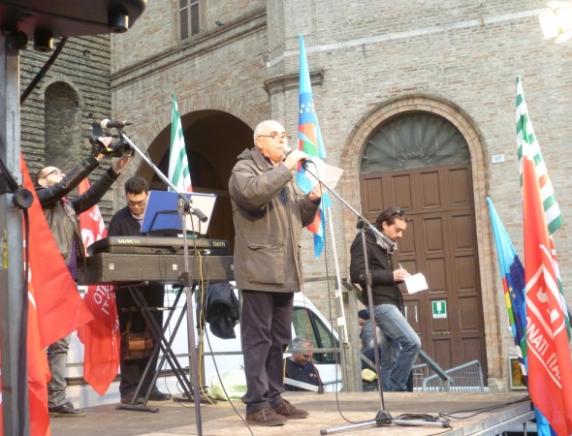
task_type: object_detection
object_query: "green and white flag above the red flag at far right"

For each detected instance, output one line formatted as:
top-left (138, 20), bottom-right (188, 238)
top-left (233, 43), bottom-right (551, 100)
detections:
top-left (516, 76), bottom-right (562, 235)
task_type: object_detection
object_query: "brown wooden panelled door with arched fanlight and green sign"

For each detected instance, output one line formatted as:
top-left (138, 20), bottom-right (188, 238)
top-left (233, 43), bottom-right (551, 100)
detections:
top-left (360, 111), bottom-right (486, 376)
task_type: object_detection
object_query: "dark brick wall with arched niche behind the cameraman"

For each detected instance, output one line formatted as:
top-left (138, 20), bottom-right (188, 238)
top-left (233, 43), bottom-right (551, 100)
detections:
top-left (20, 36), bottom-right (118, 217)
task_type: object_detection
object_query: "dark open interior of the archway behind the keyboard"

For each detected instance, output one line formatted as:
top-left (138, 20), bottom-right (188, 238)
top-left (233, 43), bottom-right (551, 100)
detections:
top-left (141, 110), bottom-right (253, 249)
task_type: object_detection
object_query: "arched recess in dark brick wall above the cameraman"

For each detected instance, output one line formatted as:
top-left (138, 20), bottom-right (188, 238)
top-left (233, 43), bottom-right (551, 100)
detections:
top-left (44, 82), bottom-right (81, 171)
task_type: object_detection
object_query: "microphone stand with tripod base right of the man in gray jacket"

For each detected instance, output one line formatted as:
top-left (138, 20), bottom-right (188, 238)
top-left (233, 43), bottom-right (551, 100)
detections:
top-left (302, 160), bottom-right (449, 435)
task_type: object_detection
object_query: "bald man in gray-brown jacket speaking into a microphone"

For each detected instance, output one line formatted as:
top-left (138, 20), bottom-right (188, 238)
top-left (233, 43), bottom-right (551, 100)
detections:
top-left (229, 120), bottom-right (321, 426)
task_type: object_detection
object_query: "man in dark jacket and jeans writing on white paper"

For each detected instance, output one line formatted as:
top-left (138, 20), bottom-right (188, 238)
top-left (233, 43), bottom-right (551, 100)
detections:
top-left (350, 207), bottom-right (421, 391)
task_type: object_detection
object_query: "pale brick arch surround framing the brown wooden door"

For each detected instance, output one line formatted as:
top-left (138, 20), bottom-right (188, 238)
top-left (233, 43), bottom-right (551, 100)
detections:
top-left (340, 95), bottom-right (505, 381)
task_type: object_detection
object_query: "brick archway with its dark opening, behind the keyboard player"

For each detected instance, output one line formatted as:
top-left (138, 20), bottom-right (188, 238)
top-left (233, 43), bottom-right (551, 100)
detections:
top-left (124, 95), bottom-right (264, 247)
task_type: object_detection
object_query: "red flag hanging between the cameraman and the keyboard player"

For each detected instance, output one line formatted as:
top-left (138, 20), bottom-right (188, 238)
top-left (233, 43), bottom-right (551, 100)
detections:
top-left (78, 179), bottom-right (120, 395)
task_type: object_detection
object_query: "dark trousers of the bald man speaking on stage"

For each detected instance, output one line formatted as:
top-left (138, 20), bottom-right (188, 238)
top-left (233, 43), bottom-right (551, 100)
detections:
top-left (240, 291), bottom-right (294, 413)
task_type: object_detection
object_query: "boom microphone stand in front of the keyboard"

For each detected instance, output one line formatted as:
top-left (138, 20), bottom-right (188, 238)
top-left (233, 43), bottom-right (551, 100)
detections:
top-left (118, 129), bottom-right (208, 436)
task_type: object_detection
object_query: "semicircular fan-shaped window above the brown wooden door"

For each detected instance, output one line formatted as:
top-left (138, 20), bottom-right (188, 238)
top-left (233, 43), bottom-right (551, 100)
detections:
top-left (361, 112), bottom-right (471, 174)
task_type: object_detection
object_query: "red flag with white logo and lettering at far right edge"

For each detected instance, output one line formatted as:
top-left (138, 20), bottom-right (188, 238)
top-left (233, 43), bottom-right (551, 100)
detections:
top-left (522, 155), bottom-right (572, 435)
